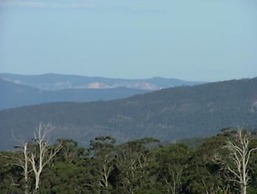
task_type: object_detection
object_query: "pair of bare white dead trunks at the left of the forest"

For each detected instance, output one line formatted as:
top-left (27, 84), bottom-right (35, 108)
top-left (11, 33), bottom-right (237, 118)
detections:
top-left (13, 124), bottom-right (62, 194)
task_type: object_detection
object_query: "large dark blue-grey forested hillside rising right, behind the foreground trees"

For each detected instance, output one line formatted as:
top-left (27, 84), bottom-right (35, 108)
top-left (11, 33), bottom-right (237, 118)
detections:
top-left (0, 78), bottom-right (257, 149)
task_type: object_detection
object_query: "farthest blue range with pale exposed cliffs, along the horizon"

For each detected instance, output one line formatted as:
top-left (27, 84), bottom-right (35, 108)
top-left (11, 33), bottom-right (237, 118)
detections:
top-left (0, 73), bottom-right (201, 90)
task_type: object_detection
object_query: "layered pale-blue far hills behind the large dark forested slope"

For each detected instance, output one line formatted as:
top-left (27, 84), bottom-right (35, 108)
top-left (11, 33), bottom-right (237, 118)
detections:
top-left (0, 74), bottom-right (199, 110)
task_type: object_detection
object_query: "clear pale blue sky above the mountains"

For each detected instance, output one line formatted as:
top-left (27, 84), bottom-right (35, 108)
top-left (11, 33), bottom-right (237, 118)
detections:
top-left (0, 0), bottom-right (257, 81)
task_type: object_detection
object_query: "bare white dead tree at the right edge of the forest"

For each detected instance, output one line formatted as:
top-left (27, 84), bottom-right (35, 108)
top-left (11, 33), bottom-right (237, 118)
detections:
top-left (221, 128), bottom-right (257, 194)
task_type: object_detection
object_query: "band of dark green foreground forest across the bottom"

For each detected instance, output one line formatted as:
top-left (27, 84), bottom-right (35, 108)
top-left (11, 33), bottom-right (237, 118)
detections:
top-left (0, 126), bottom-right (257, 194)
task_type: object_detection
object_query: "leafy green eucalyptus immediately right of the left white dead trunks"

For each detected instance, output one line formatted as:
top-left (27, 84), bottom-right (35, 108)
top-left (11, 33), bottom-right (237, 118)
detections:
top-left (40, 139), bottom-right (90, 194)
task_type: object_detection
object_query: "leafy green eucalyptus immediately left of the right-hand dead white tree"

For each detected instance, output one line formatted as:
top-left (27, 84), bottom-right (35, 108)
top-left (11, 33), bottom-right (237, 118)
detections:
top-left (183, 135), bottom-right (227, 194)
